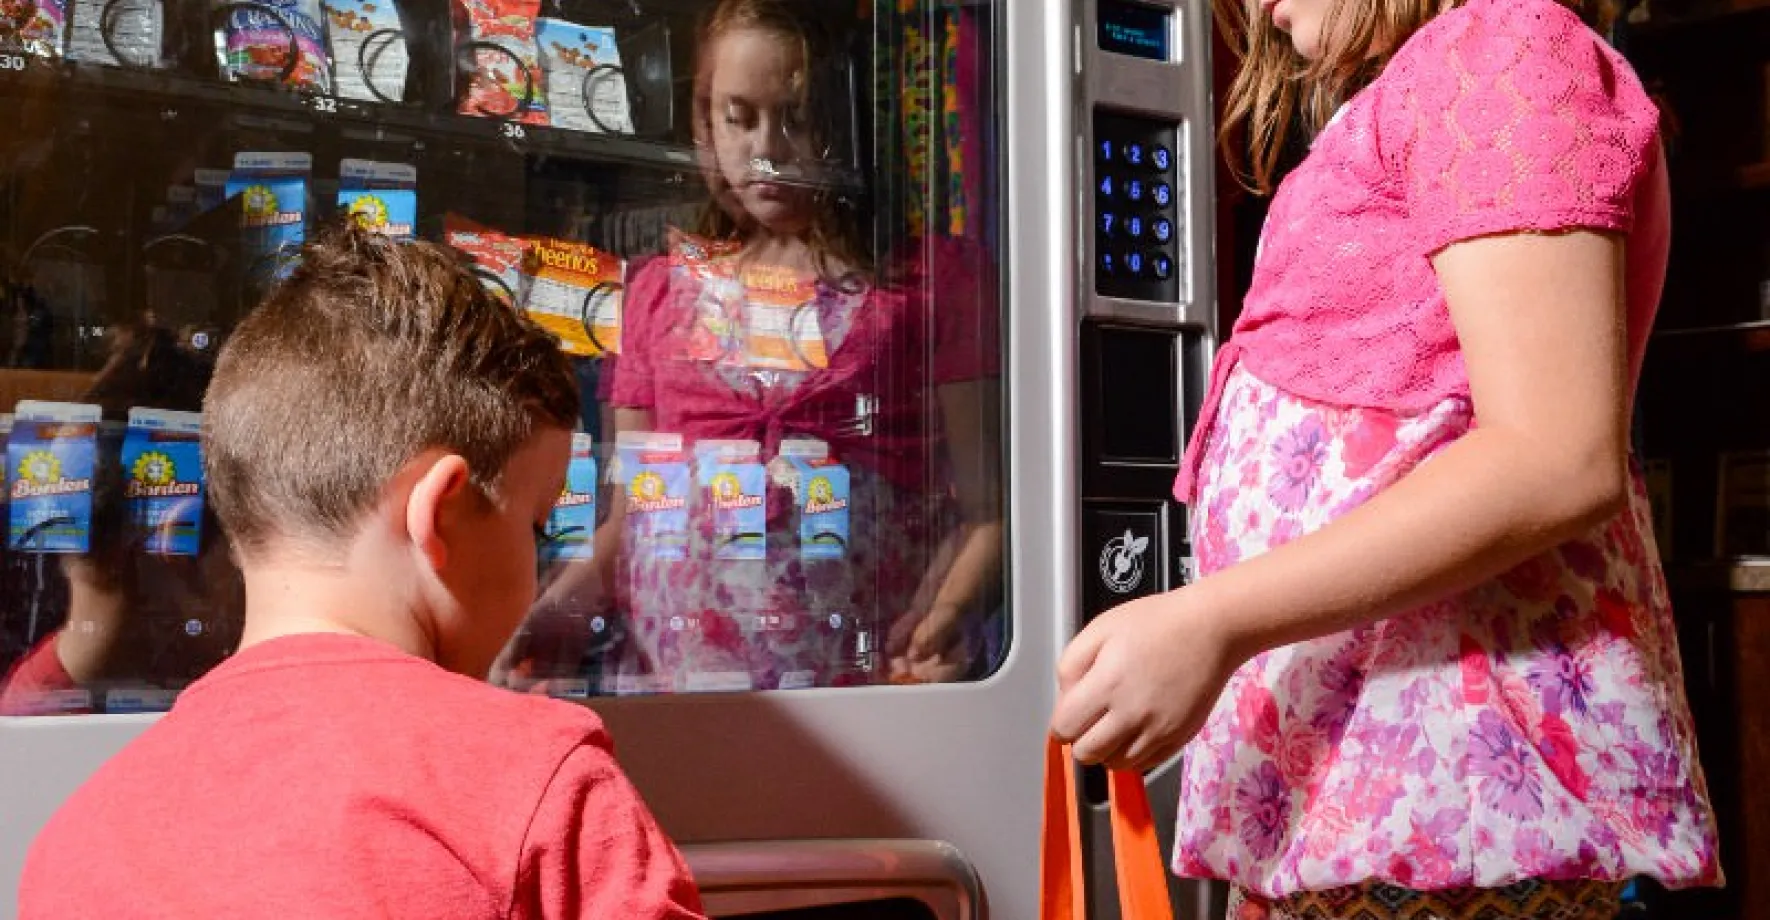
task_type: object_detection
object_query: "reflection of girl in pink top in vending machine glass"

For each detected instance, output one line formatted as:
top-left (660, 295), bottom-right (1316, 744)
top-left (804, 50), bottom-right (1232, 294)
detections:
top-left (538, 0), bottom-right (1002, 688)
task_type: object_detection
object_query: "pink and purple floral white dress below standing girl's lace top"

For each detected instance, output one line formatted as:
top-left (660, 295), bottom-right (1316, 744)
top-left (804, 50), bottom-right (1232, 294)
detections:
top-left (1174, 366), bottom-right (1720, 897)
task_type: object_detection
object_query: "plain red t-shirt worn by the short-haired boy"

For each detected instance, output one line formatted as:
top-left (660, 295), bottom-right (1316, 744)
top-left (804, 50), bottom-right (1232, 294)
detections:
top-left (19, 635), bottom-right (701, 920)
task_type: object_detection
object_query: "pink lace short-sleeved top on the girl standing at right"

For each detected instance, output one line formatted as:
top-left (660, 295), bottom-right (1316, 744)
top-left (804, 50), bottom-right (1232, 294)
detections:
top-left (1175, 0), bottom-right (1671, 501)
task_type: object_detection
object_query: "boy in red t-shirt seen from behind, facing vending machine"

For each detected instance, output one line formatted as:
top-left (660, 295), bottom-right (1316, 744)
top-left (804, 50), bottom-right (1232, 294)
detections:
top-left (19, 228), bottom-right (701, 920)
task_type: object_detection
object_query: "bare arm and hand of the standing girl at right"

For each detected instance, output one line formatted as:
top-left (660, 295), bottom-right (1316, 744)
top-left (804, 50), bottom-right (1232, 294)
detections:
top-left (1051, 232), bottom-right (1628, 768)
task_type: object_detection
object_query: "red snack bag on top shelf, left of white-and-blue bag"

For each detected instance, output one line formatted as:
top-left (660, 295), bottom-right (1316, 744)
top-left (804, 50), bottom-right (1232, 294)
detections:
top-left (455, 0), bottom-right (547, 124)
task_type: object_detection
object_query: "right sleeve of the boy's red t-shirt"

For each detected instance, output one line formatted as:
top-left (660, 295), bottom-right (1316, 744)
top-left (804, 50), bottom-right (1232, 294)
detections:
top-left (510, 743), bottom-right (703, 920)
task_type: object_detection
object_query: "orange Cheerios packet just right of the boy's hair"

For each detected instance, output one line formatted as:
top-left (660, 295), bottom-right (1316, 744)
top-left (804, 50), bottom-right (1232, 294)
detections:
top-left (522, 237), bottom-right (627, 357)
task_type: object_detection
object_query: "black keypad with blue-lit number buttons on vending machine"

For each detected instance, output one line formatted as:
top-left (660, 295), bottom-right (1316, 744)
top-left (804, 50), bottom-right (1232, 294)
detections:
top-left (1094, 111), bottom-right (1181, 303)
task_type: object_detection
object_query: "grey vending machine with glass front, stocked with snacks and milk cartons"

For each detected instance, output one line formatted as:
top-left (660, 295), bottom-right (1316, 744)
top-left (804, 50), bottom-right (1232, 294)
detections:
top-left (0, 0), bottom-right (1221, 920)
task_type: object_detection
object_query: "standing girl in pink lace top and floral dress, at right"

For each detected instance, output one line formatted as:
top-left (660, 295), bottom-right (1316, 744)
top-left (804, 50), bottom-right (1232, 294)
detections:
top-left (1053, 0), bottom-right (1720, 920)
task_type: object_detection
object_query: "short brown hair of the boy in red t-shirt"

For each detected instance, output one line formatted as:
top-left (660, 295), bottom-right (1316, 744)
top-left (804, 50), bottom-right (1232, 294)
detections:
top-left (204, 221), bottom-right (579, 559)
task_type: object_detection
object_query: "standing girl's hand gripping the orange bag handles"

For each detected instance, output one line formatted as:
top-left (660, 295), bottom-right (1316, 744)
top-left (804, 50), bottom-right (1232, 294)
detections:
top-left (1051, 586), bottom-right (1246, 771)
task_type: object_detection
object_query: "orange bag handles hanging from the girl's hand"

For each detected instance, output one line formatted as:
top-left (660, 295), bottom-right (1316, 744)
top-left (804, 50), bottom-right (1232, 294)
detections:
top-left (1039, 738), bottom-right (1174, 920)
